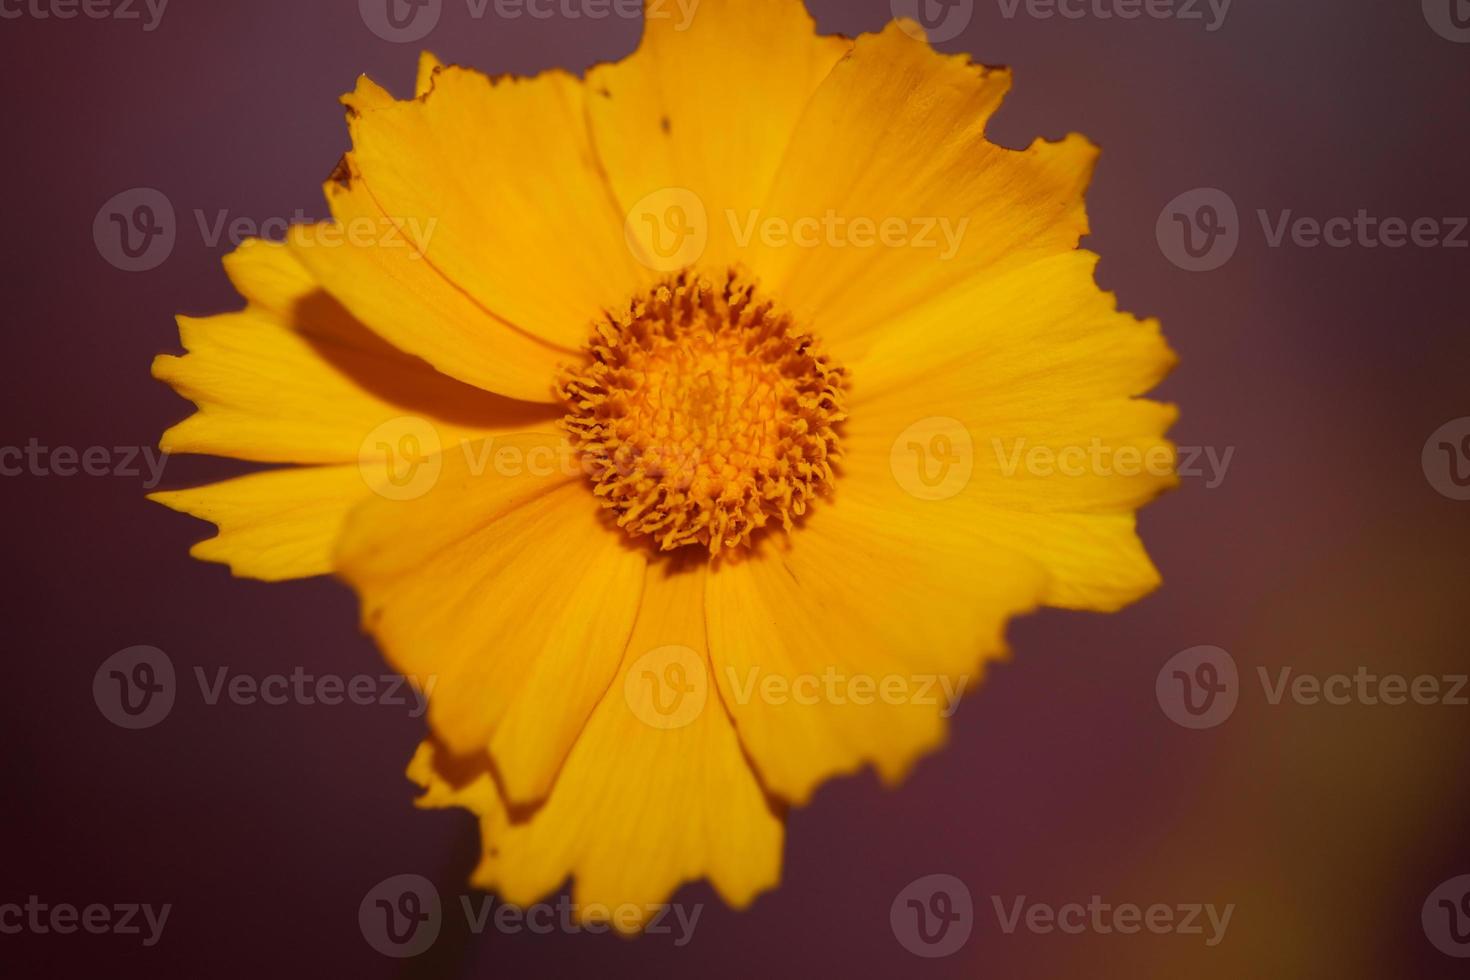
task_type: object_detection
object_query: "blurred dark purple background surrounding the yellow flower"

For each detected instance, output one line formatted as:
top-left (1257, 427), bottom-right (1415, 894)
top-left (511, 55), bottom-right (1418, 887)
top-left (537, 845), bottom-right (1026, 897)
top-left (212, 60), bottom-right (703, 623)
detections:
top-left (0, 0), bottom-right (1470, 979)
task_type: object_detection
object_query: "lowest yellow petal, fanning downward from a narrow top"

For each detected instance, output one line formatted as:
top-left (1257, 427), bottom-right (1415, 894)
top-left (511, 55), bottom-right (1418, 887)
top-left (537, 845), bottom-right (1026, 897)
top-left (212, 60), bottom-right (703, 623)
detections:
top-left (409, 566), bottom-right (782, 932)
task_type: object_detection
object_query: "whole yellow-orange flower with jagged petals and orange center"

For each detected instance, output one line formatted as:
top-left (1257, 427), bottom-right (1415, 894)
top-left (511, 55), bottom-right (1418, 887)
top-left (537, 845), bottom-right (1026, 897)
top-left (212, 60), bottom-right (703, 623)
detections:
top-left (154, 0), bottom-right (1175, 929)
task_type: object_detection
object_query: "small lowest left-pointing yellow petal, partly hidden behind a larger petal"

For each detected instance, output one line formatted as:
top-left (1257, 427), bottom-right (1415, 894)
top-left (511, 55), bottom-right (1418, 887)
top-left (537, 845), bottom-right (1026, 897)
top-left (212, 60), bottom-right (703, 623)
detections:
top-left (148, 466), bottom-right (370, 582)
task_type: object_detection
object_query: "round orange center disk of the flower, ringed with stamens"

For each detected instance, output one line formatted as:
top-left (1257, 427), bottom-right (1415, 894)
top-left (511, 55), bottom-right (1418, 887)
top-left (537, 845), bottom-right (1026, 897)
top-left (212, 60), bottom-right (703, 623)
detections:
top-left (557, 272), bottom-right (847, 554)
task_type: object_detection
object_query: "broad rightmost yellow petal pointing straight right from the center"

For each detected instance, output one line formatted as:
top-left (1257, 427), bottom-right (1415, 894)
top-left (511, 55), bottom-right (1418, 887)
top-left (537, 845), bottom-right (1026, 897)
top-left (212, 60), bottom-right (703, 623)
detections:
top-left (844, 251), bottom-right (1176, 513)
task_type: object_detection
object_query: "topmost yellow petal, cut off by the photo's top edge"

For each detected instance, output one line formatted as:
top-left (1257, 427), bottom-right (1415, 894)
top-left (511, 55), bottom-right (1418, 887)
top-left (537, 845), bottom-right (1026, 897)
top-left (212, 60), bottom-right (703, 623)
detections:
top-left (587, 0), bottom-right (851, 269)
